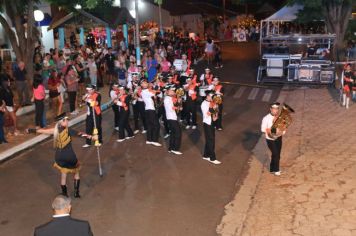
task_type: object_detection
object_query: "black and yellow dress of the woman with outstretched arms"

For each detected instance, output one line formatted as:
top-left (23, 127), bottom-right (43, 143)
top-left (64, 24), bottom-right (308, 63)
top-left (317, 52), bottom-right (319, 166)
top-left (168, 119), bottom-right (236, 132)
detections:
top-left (53, 126), bottom-right (80, 173)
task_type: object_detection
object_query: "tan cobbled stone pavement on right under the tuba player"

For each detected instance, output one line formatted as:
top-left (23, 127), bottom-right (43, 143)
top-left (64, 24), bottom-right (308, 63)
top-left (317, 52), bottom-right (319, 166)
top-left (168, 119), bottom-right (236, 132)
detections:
top-left (217, 88), bottom-right (356, 236)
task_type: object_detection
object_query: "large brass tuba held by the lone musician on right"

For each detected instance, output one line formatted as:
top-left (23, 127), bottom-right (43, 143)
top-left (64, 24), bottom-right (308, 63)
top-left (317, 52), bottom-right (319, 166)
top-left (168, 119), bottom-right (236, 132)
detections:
top-left (271, 103), bottom-right (294, 139)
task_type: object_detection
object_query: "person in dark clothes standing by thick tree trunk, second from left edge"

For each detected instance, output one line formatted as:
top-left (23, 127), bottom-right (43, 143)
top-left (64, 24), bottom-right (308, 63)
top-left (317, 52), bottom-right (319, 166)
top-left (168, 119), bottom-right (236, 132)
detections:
top-left (13, 61), bottom-right (31, 106)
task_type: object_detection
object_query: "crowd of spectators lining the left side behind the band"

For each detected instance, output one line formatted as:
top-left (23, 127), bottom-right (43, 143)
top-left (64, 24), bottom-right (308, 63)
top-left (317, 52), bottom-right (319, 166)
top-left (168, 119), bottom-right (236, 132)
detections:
top-left (0, 29), bottom-right (211, 144)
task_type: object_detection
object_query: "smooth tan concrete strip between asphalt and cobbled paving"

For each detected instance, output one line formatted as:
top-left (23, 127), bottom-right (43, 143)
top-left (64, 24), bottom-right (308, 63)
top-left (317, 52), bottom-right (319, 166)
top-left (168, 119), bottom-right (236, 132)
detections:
top-left (216, 86), bottom-right (288, 236)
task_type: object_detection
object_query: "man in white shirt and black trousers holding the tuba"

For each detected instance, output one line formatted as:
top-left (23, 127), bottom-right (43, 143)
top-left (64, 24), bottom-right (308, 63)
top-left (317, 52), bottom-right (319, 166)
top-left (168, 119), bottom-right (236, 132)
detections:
top-left (261, 102), bottom-right (284, 176)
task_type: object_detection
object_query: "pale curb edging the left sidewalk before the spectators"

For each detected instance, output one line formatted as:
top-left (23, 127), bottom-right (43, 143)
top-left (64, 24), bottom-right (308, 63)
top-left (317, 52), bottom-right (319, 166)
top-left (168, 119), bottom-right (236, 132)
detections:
top-left (0, 101), bottom-right (111, 163)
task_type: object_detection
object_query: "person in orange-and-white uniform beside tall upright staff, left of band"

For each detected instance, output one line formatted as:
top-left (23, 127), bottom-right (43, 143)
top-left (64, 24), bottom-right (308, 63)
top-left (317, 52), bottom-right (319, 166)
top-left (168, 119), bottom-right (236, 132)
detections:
top-left (83, 84), bottom-right (103, 147)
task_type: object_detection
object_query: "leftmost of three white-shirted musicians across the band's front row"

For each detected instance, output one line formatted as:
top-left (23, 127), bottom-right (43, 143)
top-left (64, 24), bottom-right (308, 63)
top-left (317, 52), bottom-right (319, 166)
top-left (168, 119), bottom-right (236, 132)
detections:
top-left (141, 81), bottom-right (162, 147)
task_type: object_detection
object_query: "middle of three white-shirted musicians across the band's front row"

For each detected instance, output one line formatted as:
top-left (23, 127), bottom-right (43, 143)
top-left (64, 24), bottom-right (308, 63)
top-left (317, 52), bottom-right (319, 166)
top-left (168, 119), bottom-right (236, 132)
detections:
top-left (164, 87), bottom-right (183, 155)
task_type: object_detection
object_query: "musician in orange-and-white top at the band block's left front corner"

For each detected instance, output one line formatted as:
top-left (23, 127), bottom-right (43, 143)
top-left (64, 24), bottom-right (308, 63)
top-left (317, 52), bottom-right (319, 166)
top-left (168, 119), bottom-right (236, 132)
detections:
top-left (116, 86), bottom-right (134, 142)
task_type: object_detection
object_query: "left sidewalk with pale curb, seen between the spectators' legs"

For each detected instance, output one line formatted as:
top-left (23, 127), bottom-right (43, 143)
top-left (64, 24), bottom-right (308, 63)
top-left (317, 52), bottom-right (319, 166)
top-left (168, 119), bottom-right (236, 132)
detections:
top-left (0, 86), bottom-right (110, 163)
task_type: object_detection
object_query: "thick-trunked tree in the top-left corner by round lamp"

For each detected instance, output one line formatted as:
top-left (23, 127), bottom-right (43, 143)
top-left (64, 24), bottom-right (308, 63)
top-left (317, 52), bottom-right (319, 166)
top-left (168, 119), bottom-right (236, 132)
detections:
top-left (0, 0), bottom-right (110, 81)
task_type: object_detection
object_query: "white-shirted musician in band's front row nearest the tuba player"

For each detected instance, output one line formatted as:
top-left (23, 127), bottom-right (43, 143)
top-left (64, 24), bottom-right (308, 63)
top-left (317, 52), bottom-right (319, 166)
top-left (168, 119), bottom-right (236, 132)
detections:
top-left (201, 91), bottom-right (221, 165)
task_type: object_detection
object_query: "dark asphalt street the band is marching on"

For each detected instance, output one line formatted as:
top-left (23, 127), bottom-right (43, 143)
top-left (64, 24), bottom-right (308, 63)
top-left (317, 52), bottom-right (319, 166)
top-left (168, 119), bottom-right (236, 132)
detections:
top-left (0, 43), bottom-right (280, 236)
